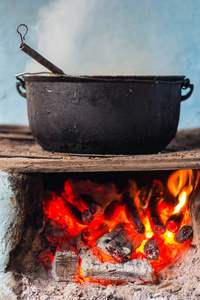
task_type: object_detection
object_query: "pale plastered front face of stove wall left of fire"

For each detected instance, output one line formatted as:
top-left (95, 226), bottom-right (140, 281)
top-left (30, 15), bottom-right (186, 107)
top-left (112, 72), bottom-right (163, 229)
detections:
top-left (0, 170), bottom-right (25, 300)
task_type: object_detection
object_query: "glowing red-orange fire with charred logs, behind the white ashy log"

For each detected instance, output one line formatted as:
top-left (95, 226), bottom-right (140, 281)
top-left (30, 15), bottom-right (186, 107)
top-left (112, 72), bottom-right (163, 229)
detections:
top-left (39, 170), bottom-right (195, 282)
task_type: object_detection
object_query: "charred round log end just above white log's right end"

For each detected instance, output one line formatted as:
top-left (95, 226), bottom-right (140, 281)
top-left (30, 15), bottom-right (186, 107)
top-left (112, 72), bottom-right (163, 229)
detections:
top-left (144, 236), bottom-right (164, 260)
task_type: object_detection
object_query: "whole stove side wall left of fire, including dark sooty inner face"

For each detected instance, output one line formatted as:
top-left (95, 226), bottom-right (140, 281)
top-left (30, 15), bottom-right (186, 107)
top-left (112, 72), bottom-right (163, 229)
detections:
top-left (0, 170), bottom-right (43, 300)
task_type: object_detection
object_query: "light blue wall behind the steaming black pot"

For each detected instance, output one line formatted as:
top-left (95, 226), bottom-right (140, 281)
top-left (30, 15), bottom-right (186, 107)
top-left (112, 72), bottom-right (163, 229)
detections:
top-left (0, 0), bottom-right (200, 128)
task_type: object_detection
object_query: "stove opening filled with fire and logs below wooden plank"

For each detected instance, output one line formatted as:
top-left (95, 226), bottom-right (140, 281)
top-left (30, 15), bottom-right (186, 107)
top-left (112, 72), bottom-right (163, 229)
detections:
top-left (32, 170), bottom-right (199, 285)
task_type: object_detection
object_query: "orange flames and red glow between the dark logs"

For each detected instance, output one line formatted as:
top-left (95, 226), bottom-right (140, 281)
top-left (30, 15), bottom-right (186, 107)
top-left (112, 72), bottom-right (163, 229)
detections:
top-left (40, 170), bottom-right (195, 283)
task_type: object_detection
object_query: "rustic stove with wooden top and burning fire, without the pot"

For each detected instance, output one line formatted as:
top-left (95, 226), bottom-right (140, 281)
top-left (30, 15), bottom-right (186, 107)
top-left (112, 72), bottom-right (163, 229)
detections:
top-left (0, 126), bottom-right (200, 299)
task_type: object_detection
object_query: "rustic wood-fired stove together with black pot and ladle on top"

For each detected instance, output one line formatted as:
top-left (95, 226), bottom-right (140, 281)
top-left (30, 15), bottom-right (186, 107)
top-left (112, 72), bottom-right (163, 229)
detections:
top-left (0, 24), bottom-right (200, 300)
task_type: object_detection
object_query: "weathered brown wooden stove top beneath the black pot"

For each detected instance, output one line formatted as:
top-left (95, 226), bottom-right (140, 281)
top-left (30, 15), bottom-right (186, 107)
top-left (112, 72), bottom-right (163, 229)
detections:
top-left (0, 129), bottom-right (200, 173)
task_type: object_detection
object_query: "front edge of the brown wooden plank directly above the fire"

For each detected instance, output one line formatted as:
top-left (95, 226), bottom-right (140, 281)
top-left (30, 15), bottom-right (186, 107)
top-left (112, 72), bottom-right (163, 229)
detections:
top-left (0, 153), bottom-right (200, 173)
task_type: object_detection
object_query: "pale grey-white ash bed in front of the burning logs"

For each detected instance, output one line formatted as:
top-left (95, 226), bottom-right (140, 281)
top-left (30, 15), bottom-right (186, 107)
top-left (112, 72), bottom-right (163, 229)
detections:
top-left (19, 247), bottom-right (200, 300)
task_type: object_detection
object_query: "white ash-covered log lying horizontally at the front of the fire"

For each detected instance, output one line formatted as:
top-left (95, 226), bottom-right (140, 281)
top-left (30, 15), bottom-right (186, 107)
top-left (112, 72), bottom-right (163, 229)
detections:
top-left (79, 249), bottom-right (154, 283)
